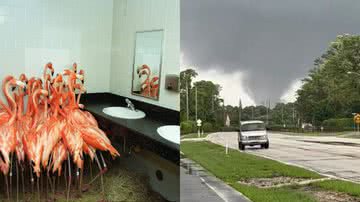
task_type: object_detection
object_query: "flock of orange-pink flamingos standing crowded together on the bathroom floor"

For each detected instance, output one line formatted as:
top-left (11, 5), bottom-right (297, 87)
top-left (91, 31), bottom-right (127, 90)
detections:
top-left (0, 63), bottom-right (119, 200)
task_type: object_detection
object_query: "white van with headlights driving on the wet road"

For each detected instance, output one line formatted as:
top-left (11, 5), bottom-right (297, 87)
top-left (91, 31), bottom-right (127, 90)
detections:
top-left (238, 121), bottom-right (269, 150)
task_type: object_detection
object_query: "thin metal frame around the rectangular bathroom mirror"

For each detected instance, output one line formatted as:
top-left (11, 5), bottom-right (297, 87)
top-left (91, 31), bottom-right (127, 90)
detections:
top-left (131, 29), bottom-right (165, 101)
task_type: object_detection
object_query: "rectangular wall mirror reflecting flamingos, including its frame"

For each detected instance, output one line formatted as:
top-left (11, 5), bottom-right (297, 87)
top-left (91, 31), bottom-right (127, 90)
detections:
top-left (131, 30), bottom-right (164, 100)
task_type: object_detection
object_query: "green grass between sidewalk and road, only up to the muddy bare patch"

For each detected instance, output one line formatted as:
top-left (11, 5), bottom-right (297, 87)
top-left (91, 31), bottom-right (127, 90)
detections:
top-left (181, 142), bottom-right (321, 180)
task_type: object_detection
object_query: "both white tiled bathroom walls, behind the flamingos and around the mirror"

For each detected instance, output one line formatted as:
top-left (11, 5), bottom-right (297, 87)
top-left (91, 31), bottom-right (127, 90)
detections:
top-left (0, 0), bottom-right (180, 110)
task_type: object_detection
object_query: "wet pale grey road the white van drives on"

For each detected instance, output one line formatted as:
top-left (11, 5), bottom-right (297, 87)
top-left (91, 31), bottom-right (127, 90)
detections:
top-left (206, 132), bottom-right (360, 182)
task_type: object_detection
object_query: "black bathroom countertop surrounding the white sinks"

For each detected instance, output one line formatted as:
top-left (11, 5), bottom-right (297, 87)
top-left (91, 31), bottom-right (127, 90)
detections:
top-left (81, 93), bottom-right (180, 151)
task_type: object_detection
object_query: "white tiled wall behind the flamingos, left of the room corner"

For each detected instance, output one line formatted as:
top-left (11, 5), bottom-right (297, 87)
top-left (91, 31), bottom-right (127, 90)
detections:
top-left (0, 0), bottom-right (113, 101)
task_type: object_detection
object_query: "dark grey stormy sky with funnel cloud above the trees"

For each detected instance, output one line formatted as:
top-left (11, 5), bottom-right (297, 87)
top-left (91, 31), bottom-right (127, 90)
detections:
top-left (181, 0), bottom-right (360, 105)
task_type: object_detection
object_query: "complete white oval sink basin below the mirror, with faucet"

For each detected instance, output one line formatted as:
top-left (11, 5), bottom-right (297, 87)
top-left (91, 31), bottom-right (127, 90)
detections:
top-left (103, 107), bottom-right (145, 119)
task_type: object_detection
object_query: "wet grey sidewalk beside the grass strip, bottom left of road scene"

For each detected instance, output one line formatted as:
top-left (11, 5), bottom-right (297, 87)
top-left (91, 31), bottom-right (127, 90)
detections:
top-left (180, 159), bottom-right (250, 202)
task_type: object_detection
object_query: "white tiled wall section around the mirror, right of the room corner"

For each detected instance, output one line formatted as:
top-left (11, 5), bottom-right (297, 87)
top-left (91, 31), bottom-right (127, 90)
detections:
top-left (110, 0), bottom-right (180, 110)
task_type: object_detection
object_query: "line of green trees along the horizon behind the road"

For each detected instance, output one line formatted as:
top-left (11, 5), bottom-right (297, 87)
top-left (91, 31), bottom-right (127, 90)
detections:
top-left (180, 34), bottom-right (360, 130)
